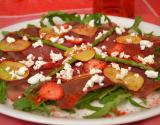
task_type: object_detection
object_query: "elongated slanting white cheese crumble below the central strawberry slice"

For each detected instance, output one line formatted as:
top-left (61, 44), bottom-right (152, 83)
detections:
top-left (83, 74), bottom-right (104, 91)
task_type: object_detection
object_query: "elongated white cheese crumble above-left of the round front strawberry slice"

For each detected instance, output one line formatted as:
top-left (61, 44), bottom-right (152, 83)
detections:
top-left (28, 72), bottom-right (52, 84)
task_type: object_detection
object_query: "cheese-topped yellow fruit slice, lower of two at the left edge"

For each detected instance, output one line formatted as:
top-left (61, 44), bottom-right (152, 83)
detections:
top-left (0, 61), bottom-right (29, 81)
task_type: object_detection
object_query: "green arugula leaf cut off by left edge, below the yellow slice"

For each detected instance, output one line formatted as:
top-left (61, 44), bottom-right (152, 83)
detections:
top-left (0, 81), bottom-right (7, 103)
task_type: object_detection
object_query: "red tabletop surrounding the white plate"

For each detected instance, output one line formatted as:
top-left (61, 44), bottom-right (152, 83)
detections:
top-left (0, 0), bottom-right (160, 125)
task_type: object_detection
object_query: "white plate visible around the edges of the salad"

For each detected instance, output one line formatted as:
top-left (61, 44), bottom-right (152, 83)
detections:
top-left (0, 16), bottom-right (160, 125)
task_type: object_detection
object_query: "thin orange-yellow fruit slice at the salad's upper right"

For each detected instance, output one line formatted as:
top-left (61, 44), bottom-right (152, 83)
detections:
top-left (116, 35), bottom-right (141, 44)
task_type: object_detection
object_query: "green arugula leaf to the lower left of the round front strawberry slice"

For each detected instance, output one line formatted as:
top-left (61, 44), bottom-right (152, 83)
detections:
top-left (13, 97), bottom-right (50, 114)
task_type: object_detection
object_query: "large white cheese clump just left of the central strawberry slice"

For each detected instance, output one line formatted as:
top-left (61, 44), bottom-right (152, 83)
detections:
top-left (56, 63), bottom-right (74, 80)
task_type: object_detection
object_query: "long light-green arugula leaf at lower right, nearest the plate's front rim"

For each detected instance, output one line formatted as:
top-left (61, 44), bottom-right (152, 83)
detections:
top-left (84, 93), bottom-right (131, 118)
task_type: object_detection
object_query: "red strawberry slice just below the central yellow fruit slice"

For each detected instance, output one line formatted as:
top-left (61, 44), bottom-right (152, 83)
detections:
top-left (83, 59), bottom-right (106, 73)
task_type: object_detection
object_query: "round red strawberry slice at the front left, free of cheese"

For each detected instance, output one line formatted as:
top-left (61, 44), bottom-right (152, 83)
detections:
top-left (39, 81), bottom-right (64, 100)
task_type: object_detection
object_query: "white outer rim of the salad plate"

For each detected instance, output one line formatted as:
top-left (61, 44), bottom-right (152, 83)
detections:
top-left (0, 16), bottom-right (160, 125)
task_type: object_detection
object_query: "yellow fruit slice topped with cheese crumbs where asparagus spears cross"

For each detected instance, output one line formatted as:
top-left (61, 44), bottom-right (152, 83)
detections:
top-left (64, 46), bottom-right (95, 61)
